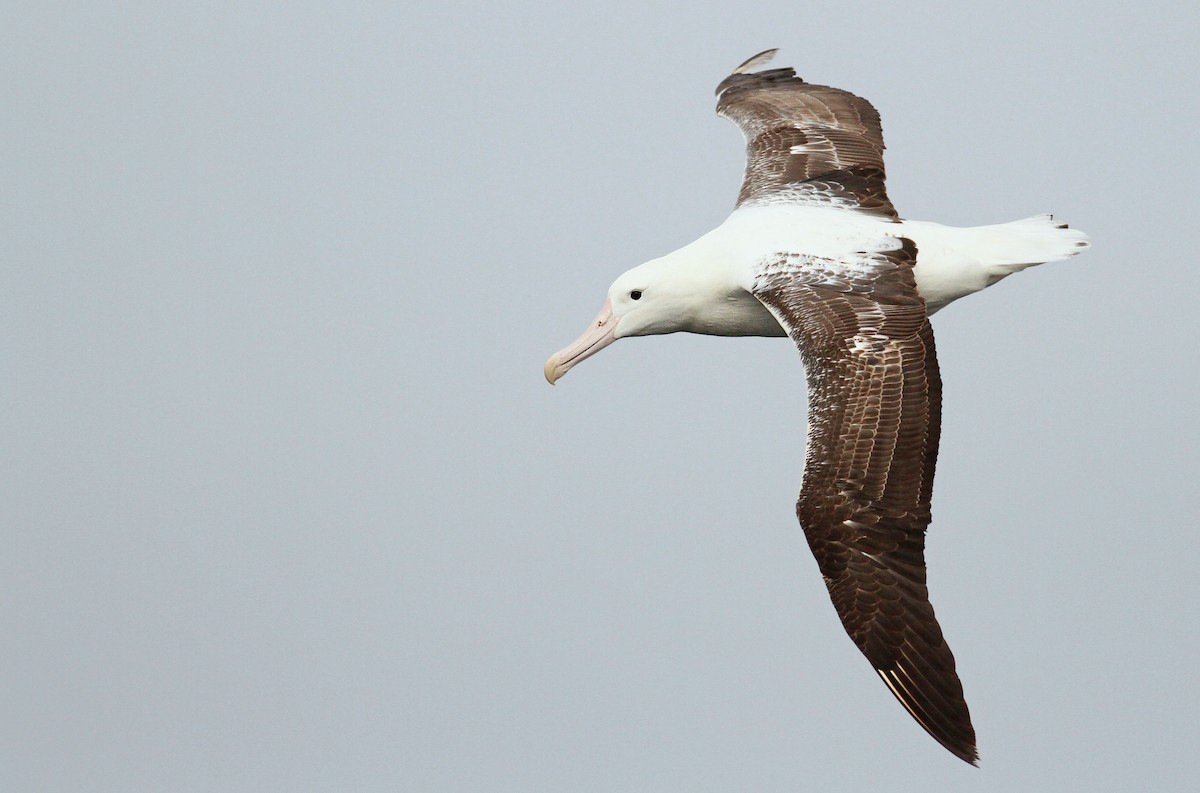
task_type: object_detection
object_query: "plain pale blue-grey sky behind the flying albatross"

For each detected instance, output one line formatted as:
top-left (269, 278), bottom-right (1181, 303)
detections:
top-left (0, 0), bottom-right (1200, 792)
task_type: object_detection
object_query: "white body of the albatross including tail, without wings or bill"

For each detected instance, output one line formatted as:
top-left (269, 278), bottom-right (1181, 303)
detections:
top-left (610, 204), bottom-right (1087, 337)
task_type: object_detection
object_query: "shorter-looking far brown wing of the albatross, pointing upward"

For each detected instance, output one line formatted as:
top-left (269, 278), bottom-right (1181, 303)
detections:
top-left (716, 49), bottom-right (896, 218)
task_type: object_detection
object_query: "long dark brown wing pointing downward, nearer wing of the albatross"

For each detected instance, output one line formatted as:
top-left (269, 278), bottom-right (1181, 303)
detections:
top-left (754, 238), bottom-right (978, 763)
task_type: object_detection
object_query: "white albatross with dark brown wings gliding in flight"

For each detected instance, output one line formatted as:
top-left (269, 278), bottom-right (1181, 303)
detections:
top-left (545, 49), bottom-right (1088, 764)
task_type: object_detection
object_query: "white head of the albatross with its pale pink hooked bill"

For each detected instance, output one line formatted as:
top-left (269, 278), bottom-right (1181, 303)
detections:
top-left (545, 258), bottom-right (698, 385)
